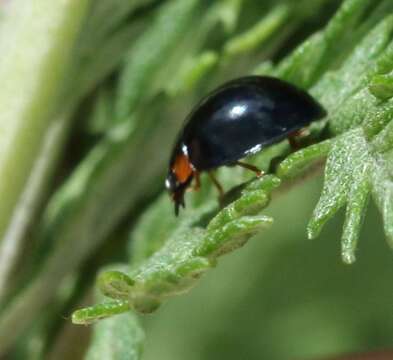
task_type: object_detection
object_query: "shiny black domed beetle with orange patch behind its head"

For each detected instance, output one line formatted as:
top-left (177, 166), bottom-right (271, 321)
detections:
top-left (165, 76), bottom-right (326, 215)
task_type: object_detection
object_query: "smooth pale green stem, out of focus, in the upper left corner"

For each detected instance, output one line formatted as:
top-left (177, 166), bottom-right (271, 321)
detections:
top-left (0, 0), bottom-right (88, 242)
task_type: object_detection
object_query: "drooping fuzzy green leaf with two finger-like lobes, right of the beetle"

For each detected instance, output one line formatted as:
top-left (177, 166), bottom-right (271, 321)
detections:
top-left (307, 129), bottom-right (372, 263)
